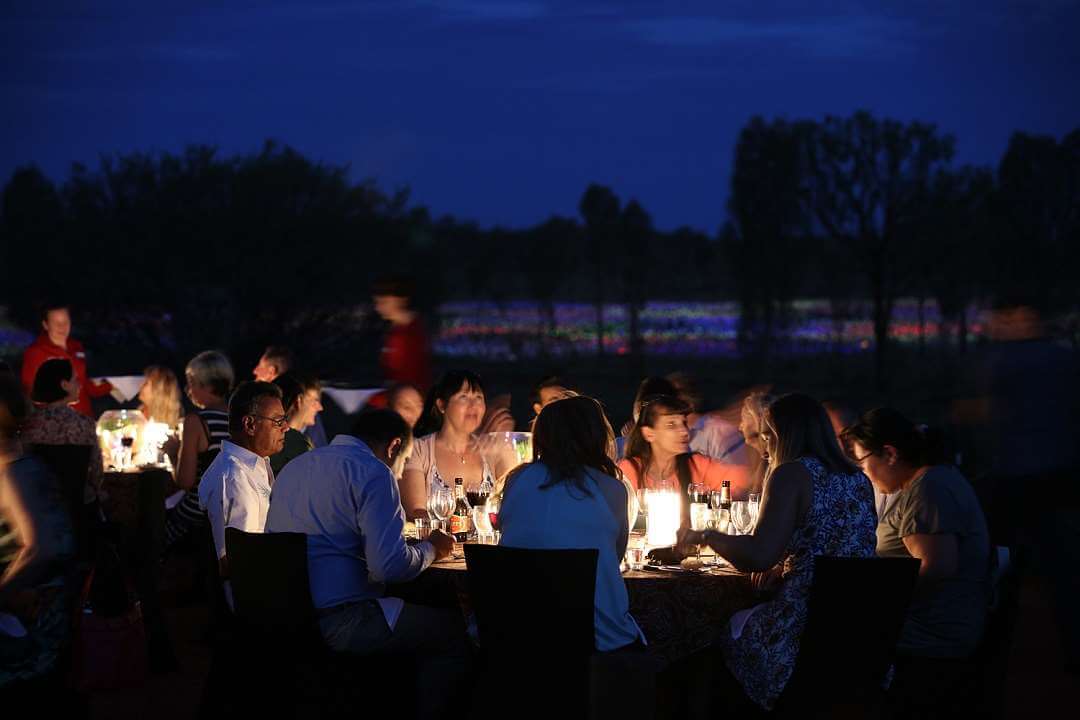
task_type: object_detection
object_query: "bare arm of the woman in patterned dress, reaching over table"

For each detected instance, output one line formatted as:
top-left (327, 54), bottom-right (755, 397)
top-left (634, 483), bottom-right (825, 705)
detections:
top-left (679, 462), bottom-right (810, 572)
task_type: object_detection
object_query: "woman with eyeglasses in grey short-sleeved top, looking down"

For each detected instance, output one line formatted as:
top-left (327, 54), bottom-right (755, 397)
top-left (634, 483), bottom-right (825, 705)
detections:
top-left (843, 408), bottom-right (990, 658)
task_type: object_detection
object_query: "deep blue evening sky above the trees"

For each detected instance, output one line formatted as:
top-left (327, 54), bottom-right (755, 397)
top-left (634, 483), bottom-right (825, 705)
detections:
top-left (0, 0), bottom-right (1080, 232)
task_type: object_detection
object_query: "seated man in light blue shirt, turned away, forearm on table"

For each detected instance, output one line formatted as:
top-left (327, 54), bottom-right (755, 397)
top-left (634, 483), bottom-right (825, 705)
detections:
top-left (267, 410), bottom-right (469, 717)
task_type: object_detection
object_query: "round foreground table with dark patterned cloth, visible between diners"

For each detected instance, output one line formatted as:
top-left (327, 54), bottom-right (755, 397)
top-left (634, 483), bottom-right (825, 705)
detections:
top-left (387, 559), bottom-right (759, 664)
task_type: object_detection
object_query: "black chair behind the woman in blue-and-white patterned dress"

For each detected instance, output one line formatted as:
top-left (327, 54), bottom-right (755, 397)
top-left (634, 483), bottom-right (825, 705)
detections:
top-left (775, 556), bottom-right (919, 717)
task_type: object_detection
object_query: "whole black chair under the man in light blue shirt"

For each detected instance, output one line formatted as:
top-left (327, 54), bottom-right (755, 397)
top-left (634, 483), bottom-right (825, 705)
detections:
top-left (218, 528), bottom-right (410, 717)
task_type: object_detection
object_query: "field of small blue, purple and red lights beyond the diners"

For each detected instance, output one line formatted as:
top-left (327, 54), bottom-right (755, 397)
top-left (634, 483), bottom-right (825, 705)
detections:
top-left (435, 299), bottom-right (984, 361)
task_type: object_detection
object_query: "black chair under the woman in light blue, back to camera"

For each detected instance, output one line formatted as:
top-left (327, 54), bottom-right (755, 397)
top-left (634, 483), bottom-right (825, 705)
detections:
top-left (464, 544), bottom-right (656, 717)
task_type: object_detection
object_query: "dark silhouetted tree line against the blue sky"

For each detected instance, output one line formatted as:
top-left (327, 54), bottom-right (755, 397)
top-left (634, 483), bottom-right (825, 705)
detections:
top-left (0, 111), bottom-right (1080, 388)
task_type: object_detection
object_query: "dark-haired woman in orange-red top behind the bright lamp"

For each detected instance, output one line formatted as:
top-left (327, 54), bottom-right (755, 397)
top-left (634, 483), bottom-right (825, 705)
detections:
top-left (619, 395), bottom-right (750, 499)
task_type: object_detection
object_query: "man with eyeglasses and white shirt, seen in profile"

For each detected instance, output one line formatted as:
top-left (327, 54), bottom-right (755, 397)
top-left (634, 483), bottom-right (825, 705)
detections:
top-left (199, 381), bottom-right (288, 608)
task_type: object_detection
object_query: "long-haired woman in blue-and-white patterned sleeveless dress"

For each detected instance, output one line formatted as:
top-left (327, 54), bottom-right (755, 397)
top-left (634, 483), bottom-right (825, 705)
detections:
top-left (680, 394), bottom-right (877, 710)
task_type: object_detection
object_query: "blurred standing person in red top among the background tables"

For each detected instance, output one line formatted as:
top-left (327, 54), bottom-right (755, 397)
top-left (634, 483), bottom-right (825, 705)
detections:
top-left (372, 276), bottom-right (431, 392)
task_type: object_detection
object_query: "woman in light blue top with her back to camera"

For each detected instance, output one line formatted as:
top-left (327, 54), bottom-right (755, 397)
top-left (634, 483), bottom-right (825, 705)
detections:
top-left (499, 396), bottom-right (645, 652)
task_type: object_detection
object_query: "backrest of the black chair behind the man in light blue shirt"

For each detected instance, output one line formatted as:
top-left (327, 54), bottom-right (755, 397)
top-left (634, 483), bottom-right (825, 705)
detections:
top-left (225, 528), bottom-right (315, 646)
